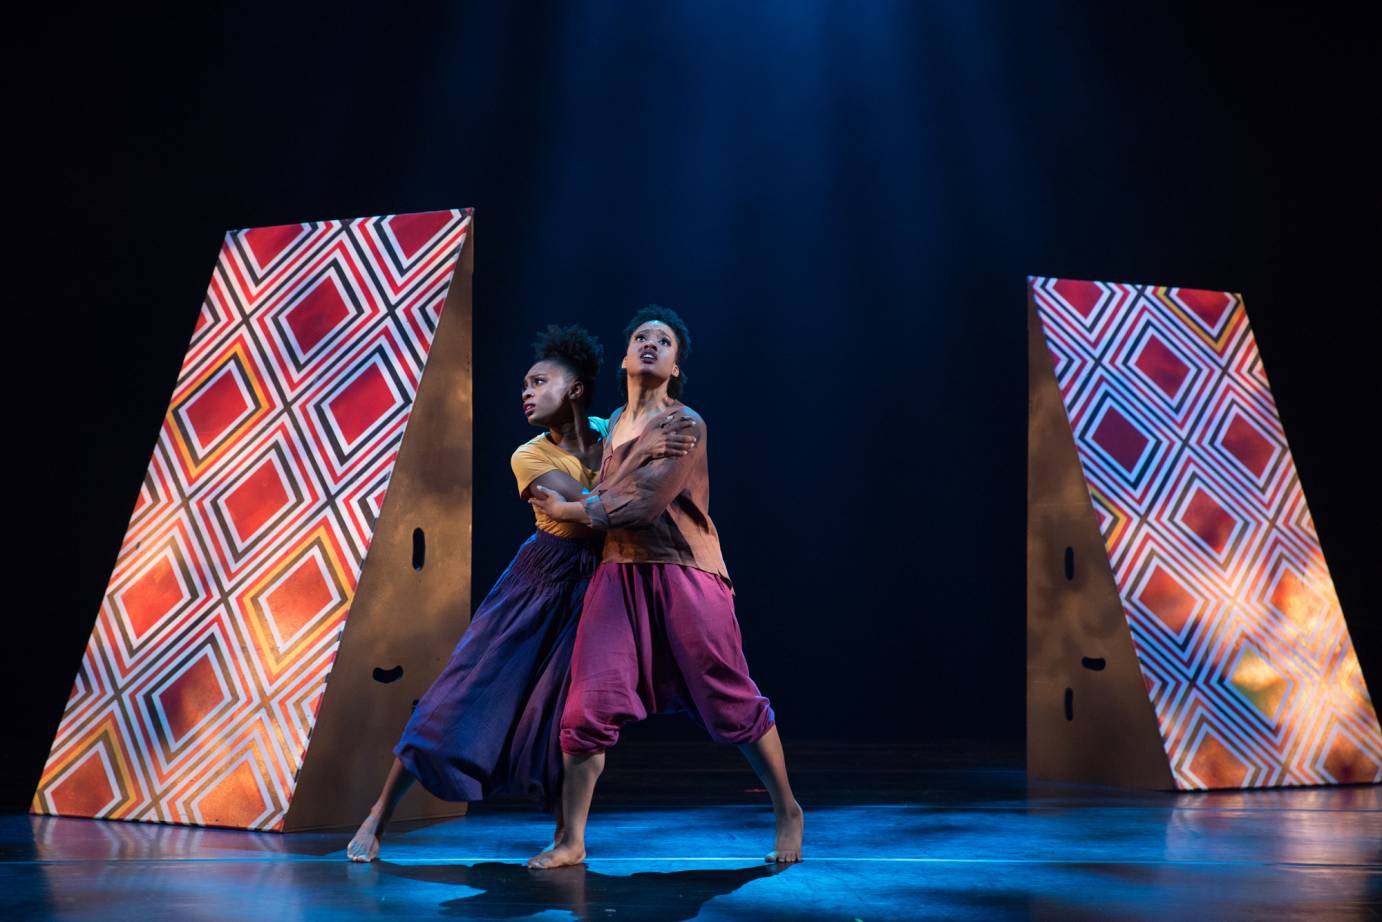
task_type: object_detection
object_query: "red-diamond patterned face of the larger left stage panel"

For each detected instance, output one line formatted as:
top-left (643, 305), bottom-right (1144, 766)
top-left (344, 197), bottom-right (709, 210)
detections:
top-left (33, 210), bottom-right (471, 829)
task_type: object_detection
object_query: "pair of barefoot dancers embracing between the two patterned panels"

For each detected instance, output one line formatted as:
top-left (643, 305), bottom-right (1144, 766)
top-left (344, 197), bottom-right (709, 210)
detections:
top-left (346, 305), bottom-right (803, 868)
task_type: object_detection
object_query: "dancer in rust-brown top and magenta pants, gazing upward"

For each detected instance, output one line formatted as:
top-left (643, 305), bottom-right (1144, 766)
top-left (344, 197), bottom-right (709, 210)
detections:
top-left (529, 305), bottom-right (803, 868)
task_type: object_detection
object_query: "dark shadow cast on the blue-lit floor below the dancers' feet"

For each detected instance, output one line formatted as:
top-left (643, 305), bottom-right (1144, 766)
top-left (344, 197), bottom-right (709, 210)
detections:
top-left (379, 861), bottom-right (791, 922)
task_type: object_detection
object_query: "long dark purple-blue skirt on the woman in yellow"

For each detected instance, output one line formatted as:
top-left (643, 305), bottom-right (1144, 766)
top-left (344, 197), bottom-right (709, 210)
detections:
top-left (394, 531), bottom-right (600, 811)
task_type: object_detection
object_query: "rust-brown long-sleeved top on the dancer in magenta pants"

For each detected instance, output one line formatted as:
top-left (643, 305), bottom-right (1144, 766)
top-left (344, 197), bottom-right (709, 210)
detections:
top-left (586, 401), bottom-right (730, 582)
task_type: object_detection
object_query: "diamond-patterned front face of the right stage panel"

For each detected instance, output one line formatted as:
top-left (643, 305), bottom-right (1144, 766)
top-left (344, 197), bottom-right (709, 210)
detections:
top-left (1030, 278), bottom-right (1382, 789)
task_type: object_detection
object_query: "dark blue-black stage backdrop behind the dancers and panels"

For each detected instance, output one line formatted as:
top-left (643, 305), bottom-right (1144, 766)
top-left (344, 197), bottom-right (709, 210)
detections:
top-left (3, 0), bottom-right (1382, 807)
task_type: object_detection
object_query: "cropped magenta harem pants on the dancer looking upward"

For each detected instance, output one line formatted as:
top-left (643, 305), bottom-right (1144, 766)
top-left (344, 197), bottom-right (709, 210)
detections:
top-left (561, 564), bottom-right (773, 755)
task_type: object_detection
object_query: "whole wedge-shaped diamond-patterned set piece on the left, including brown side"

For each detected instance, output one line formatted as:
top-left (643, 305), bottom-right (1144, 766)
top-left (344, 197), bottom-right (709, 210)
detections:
top-left (32, 209), bottom-right (474, 831)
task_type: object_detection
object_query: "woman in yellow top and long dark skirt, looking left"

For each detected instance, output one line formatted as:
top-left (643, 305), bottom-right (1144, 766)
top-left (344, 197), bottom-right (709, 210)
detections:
top-left (346, 326), bottom-right (694, 861)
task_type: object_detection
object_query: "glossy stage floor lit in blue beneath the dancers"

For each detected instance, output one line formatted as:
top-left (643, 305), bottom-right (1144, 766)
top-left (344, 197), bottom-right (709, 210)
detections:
top-left (0, 744), bottom-right (1382, 922)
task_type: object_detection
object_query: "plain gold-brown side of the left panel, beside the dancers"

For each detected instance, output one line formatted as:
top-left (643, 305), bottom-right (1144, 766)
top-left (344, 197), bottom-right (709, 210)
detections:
top-left (283, 218), bottom-right (475, 831)
